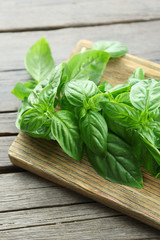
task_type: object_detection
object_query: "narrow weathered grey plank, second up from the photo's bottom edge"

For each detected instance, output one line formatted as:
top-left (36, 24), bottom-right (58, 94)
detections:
top-left (0, 202), bottom-right (120, 231)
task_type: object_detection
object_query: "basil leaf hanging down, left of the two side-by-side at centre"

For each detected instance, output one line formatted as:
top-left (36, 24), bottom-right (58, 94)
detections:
top-left (51, 110), bottom-right (83, 161)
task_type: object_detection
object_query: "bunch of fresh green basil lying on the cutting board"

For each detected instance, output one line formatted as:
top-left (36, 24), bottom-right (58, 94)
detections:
top-left (12, 38), bottom-right (160, 188)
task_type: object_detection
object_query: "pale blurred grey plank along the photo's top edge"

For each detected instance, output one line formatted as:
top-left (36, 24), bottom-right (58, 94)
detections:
top-left (0, 0), bottom-right (160, 31)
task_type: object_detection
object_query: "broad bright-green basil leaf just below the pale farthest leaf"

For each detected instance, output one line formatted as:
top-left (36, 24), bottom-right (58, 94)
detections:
top-left (68, 50), bottom-right (110, 84)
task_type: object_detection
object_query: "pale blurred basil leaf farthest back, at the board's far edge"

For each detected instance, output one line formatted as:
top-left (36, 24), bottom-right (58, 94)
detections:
top-left (92, 41), bottom-right (128, 58)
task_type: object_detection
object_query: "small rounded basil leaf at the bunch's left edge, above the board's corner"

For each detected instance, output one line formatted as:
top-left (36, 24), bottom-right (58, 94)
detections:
top-left (20, 108), bottom-right (47, 132)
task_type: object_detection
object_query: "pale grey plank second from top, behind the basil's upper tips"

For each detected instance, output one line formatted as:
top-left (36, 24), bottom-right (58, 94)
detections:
top-left (0, 20), bottom-right (160, 71)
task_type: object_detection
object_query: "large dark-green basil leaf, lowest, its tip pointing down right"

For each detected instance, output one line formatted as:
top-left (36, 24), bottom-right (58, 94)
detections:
top-left (87, 133), bottom-right (143, 188)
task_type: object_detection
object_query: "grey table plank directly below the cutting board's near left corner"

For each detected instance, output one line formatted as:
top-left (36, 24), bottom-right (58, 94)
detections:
top-left (0, 172), bottom-right (93, 213)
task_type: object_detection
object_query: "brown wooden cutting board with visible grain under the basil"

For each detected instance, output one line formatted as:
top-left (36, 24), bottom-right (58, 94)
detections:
top-left (9, 40), bottom-right (160, 229)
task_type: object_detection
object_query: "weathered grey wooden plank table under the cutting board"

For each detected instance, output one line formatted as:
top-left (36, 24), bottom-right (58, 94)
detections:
top-left (0, 0), bottom-right (160, 240)
